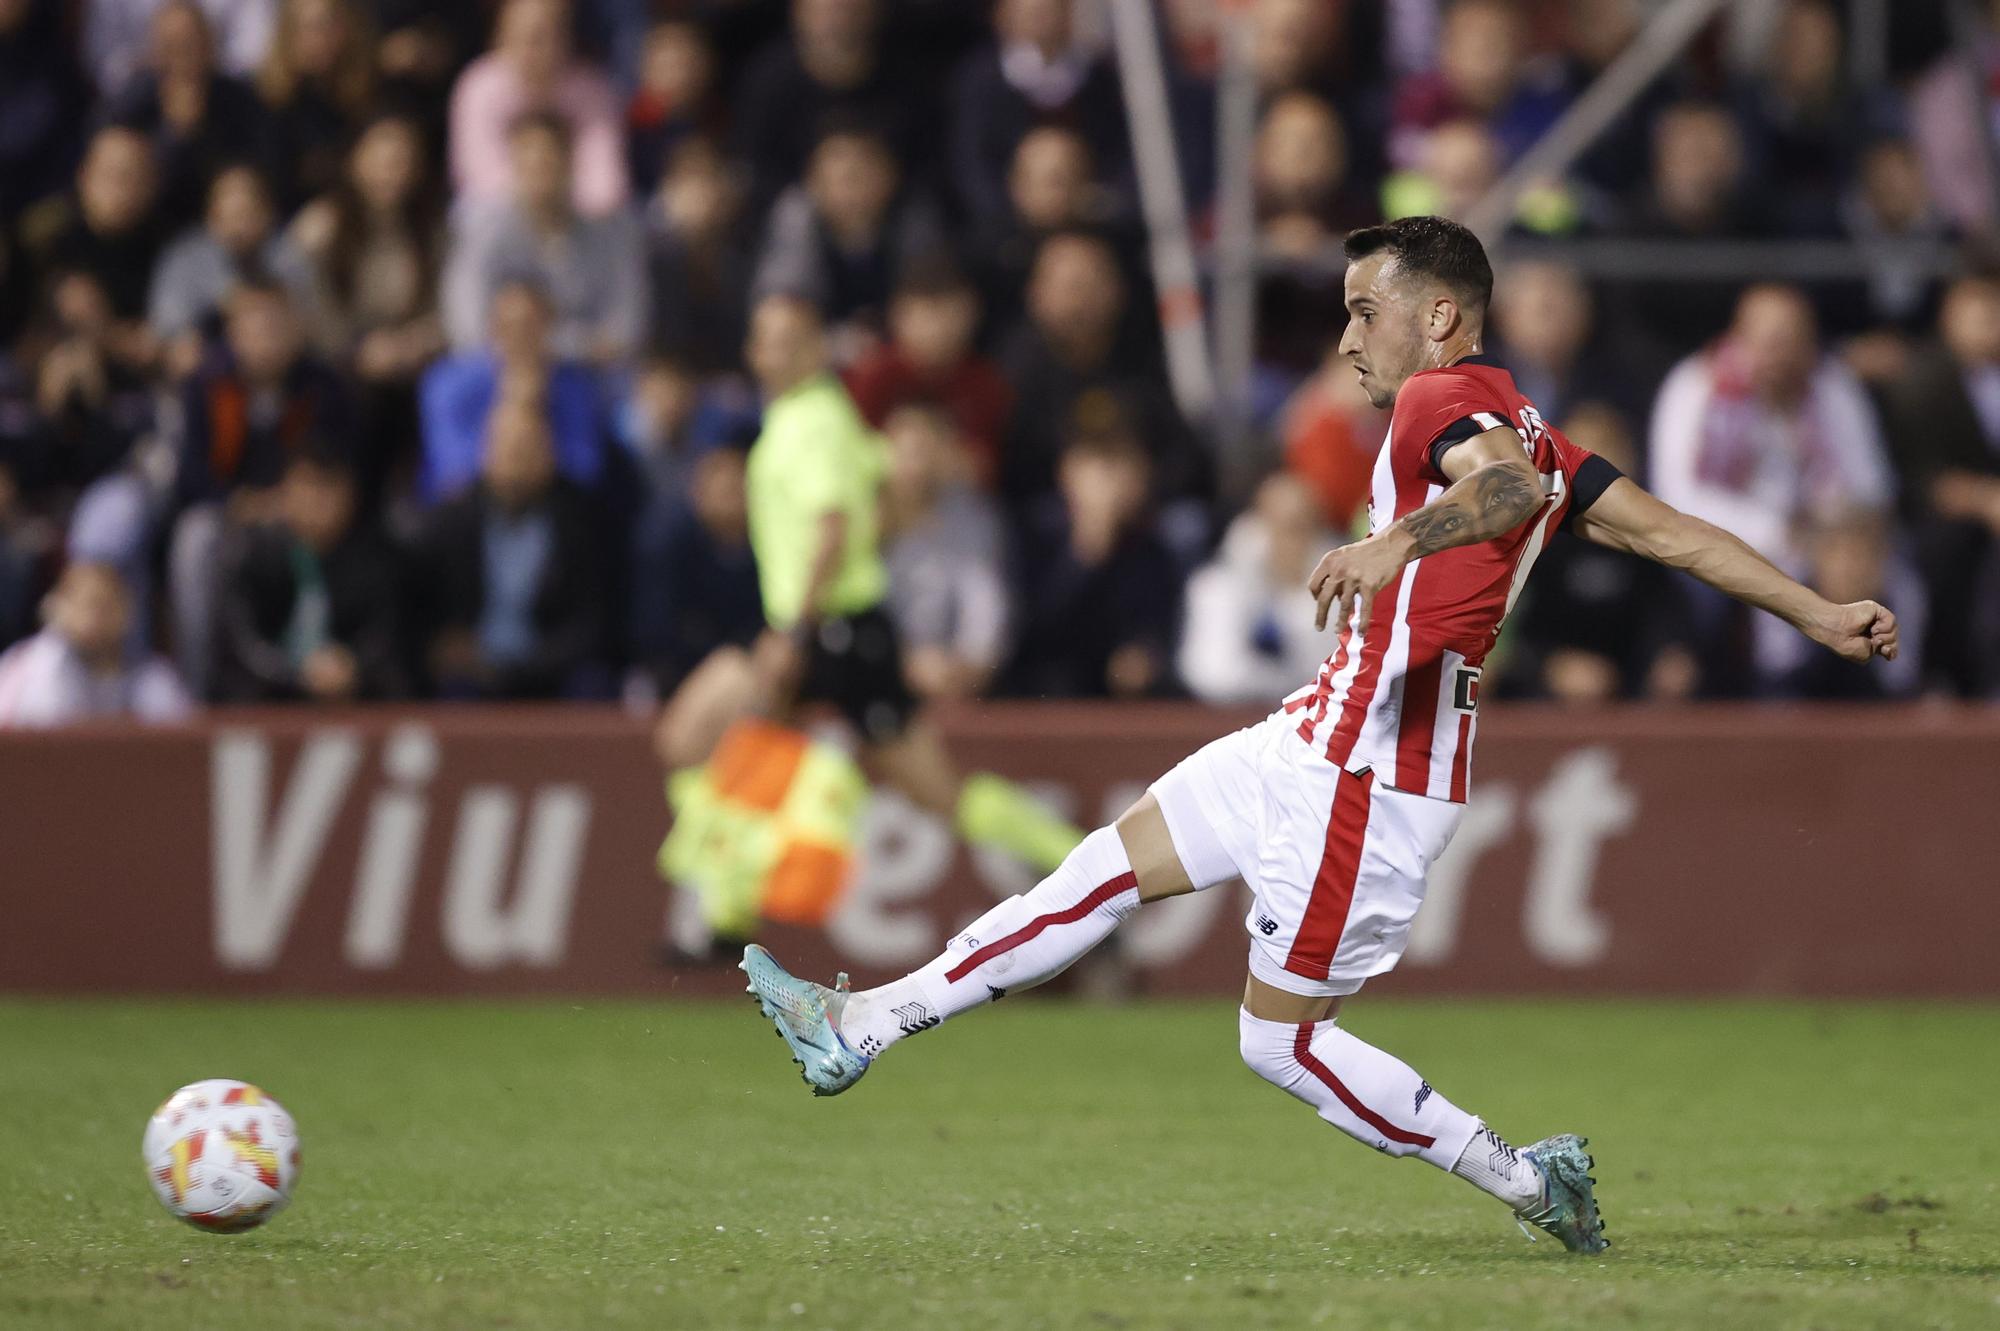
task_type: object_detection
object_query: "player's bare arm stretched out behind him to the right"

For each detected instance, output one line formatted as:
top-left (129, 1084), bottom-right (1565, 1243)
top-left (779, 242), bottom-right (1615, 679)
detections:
top-left (1570, 476), bottom-right (1898, 662)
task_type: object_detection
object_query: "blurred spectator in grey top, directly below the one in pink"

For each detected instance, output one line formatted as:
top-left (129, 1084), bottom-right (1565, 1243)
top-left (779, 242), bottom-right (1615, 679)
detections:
top-left (444, 110), bottom-right (646, 366)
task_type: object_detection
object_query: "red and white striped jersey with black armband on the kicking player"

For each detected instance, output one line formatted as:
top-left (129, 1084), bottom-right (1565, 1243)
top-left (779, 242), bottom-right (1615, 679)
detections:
top-left (1282, 356), bottom-right (1618, 801)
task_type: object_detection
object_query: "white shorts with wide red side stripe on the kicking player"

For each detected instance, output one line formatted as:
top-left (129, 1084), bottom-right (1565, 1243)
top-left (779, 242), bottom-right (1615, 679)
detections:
top-left (1152, 711), bottom-right (1464, 997)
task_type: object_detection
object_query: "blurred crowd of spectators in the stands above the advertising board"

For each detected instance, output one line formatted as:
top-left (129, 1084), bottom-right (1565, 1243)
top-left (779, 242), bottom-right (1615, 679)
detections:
top-left (0, 0), bottom-right (2000, 723)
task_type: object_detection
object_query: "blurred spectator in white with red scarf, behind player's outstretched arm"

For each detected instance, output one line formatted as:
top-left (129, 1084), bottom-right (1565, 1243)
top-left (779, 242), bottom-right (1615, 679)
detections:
top-left (1648, 286), bottom-right (1910, 687)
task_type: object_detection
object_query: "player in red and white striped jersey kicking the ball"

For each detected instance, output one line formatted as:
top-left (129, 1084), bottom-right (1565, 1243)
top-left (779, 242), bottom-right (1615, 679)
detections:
top-left (742, 218), bottom-right (1896, 1253)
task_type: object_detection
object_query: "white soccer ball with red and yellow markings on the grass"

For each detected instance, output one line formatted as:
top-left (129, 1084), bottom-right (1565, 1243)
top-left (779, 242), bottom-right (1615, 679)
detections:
top-left (142, 1077), bottom-right (298, 1233)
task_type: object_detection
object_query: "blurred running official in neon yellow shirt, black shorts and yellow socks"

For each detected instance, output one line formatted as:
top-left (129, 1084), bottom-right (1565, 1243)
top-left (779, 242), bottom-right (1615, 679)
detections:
top-left (664, 294), bottom-right (1082, 923)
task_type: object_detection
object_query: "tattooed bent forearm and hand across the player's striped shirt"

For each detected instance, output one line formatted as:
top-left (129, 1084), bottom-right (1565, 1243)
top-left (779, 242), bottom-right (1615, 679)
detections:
top-left (1306, 426), bottom-right (1542, 630)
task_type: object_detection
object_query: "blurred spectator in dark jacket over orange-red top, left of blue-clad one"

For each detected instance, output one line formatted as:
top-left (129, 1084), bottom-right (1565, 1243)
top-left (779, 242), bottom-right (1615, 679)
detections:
top-left (168, 278), bottom-right (364, 697)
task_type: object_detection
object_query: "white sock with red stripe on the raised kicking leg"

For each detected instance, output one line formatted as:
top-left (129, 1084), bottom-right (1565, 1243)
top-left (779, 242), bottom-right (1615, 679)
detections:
top-left (840, 827), bottom-right (1138, 1057)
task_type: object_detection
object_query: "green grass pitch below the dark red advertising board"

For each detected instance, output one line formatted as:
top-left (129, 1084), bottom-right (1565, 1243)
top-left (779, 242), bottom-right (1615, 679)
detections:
top-left (0, 999), bottom-right (2000, 1331)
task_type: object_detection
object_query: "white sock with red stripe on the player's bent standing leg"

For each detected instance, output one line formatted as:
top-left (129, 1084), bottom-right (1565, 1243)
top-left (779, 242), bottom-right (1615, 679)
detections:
top-left (1238, 1009), bottom-right (1480, 1169)
